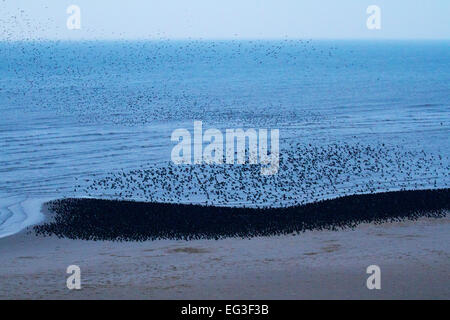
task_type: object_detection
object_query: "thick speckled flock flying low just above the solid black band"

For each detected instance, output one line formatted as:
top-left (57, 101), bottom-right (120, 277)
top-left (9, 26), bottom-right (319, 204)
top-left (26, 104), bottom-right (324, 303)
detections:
top-left (79, 143), bottom-right (450, 208)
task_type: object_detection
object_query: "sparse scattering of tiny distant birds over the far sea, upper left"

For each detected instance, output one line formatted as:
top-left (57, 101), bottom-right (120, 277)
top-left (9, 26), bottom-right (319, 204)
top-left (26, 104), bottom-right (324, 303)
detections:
top-left (0, 5), bottom-right (367, 126)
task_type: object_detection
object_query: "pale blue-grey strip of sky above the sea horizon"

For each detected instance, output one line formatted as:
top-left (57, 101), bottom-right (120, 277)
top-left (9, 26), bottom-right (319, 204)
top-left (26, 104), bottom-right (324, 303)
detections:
top-left (0, 0), bottom-right (450, 40)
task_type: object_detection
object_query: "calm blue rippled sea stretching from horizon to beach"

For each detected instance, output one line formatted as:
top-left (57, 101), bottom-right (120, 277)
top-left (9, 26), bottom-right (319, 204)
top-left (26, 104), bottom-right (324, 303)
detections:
top-left (0, 40), bottom-right (450, 236)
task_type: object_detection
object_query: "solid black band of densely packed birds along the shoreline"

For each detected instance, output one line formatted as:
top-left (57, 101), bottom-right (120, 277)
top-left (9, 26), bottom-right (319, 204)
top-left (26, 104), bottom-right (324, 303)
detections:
top-left (34, 189), bottom-right (450, 241)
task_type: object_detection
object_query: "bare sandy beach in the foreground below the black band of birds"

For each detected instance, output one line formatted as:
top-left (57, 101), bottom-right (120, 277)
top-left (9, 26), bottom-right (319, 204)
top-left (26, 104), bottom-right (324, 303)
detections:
top-left (0, 215), bottom-right (450, 299)
